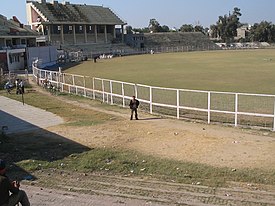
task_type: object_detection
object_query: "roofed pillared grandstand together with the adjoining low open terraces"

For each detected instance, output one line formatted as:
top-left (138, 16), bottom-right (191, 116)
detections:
top-left (27, 0), bottom-right (220, 57)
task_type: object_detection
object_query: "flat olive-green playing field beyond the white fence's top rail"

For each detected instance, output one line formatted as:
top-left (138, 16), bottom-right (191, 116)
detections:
top-left (66, 49), bottom-right (275, 94)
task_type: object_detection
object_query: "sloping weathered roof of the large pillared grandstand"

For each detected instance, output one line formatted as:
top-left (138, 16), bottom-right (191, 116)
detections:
top-left (27, 1), bottom-right (126, 25)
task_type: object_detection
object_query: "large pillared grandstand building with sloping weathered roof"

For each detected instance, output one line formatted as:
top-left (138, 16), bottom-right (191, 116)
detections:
top-left (27, 0), bottom-right (126, 45)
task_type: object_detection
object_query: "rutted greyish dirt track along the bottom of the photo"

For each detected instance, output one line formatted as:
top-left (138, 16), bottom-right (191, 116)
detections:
top-left (25, 174), bottom-right (275, 206)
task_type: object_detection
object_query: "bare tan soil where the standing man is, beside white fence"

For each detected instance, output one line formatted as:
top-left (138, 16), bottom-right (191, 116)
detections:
top-left (50, 97), bottom-right (275, 169)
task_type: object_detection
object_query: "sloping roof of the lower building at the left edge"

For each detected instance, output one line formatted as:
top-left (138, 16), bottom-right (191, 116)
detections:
top-left (0, 14), bottom-right (38, 37)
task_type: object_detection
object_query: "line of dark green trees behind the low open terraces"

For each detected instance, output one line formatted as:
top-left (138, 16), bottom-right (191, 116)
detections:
top-left (127, 7), bottom-right (275, 43)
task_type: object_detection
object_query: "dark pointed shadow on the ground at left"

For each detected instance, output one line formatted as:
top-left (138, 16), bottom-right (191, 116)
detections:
top-left (0, 111), bottom-right (91, 181)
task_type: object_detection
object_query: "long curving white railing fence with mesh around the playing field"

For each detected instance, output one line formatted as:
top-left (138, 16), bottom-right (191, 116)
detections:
top-left (33, 67), bottom-right (275, 131)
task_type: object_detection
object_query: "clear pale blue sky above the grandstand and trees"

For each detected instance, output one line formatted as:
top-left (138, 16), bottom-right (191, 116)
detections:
top-left (0, 0), bottom-right (275, 28)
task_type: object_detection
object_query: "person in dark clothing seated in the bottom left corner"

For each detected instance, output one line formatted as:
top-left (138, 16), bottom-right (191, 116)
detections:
top-left (0, 159), bottom-right (30, 206)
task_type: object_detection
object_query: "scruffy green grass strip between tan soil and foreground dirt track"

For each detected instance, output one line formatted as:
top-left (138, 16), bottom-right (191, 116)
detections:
top-left (12, 148), bottom-right (275, 186)
